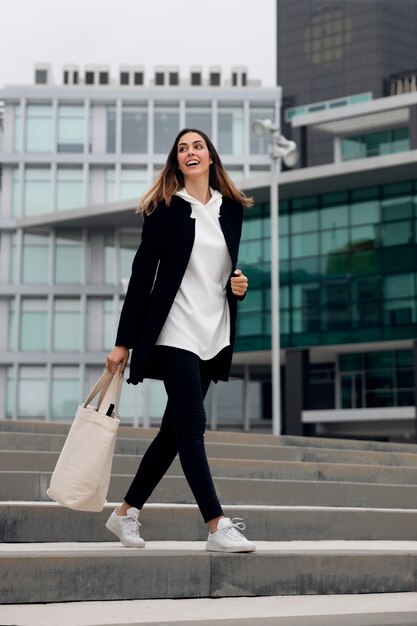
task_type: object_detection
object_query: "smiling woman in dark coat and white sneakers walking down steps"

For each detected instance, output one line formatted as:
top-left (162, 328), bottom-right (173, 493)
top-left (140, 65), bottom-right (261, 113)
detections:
top-left (106, 128), bottom-right (255, 552)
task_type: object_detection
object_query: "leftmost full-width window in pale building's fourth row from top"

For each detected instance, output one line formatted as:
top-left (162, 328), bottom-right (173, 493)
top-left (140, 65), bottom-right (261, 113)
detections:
top-left (19, 298), bottom-right (48, 351)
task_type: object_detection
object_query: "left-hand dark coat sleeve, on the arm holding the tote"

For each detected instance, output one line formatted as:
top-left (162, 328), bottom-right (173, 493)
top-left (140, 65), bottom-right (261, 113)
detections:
top-left (115, 206), bottom-right (163, 348)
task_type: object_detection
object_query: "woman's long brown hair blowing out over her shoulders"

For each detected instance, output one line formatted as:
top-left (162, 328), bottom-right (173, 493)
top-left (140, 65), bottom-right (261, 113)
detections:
top-left (137, 128), bottom-right (253, 215)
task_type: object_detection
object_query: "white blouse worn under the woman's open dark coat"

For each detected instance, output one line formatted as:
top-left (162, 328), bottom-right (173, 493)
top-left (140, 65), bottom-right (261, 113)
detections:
top-left (156, 189), bottom-right (232, 360)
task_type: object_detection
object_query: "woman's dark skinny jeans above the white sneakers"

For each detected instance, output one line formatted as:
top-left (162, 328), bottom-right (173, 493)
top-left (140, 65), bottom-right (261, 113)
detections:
top-left (125, 346), bottom-right (223, 522)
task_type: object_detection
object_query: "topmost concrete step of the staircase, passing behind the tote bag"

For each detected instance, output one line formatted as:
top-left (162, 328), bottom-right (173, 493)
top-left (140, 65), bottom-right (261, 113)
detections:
top-left (0, 420), bottom-right (417, 454)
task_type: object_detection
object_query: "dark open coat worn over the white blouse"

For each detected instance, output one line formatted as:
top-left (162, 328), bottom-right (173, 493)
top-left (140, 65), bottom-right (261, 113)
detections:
top-left (116, 196), bottom-right (243, 385)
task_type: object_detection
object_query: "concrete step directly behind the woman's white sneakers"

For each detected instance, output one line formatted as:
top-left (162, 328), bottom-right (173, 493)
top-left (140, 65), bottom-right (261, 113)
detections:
top-left (4, 502), bottom-right (417, 540)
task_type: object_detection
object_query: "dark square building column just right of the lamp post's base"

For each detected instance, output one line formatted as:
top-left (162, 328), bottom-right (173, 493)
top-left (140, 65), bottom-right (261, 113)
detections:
top-left (283, 348), bottom-right (310, 435)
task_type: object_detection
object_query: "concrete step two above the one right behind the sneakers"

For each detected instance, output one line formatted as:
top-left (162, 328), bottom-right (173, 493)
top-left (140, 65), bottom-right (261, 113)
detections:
top-left (5, 450), bottom-right (417, 485)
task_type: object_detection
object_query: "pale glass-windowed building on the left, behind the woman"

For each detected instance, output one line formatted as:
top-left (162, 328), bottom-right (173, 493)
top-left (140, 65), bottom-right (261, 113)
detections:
top-left (0, 66), bottom-right (280, 428)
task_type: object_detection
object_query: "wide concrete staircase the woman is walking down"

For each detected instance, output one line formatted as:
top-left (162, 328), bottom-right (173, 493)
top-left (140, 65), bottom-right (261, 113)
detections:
top-left (0, 421), bottom-right (417, 608)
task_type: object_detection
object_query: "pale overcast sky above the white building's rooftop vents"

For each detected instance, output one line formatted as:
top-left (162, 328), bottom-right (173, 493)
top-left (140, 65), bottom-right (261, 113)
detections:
top-left (0, 0), bottom-right (276, 87)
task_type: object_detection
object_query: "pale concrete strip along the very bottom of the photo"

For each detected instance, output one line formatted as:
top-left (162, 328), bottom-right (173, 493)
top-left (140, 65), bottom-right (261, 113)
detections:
top-left (1, 592), bottom-right (417, 626)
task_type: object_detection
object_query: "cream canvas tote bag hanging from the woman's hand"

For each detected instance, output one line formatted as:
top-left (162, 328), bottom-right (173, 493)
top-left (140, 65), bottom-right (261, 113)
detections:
top-left (47, 370), bottom-right (123, 511)
